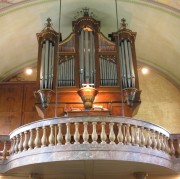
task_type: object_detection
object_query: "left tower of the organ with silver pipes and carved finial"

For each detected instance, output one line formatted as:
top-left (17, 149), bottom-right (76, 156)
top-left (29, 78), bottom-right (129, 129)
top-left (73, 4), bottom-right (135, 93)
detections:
top-left (37, 18), bottom-right (59, 89)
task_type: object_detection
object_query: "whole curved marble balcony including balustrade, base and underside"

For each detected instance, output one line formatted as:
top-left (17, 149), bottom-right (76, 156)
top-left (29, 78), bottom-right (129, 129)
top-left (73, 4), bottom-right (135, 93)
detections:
top-left (0, 116), bottom-right (180, 179)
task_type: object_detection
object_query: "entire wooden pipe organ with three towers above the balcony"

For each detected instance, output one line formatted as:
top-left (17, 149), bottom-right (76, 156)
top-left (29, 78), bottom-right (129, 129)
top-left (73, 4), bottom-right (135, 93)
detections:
top-left (35, 9), bottom-right (141, 117)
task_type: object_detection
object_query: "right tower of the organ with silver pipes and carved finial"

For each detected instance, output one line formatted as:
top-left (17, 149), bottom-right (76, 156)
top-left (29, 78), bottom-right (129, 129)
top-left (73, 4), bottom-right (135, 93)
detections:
top-left (110, 18), bottom-right (139, 89)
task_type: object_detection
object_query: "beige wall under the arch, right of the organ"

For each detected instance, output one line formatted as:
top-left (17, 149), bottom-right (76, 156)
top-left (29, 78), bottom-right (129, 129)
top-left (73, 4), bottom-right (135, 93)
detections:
top-left (135, 70), bottom-right (180, 133)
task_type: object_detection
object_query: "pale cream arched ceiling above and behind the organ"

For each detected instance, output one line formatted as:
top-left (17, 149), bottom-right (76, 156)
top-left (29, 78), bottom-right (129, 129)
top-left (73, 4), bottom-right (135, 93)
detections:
top-left (0, 0), bottom-right (180, 86)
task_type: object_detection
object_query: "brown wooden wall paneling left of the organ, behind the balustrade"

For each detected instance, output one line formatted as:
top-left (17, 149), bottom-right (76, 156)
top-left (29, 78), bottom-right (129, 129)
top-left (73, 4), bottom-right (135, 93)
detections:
top-left (0, 82), bottom-right (39, 135)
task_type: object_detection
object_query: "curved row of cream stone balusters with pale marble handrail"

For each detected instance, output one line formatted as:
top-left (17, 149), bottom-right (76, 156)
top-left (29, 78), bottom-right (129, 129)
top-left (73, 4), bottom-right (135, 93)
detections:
top-left (0, 116), bottom-right (180, 173)
